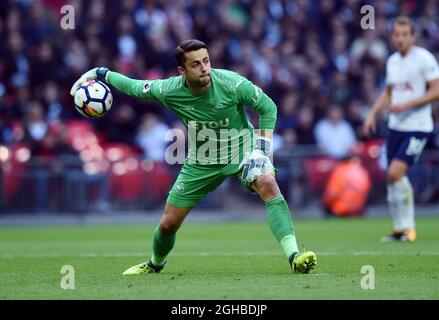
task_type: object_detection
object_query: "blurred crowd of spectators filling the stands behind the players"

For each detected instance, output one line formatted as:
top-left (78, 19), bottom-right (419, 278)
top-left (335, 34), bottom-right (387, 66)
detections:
top-left (0, 0), bottom-right (439, 210)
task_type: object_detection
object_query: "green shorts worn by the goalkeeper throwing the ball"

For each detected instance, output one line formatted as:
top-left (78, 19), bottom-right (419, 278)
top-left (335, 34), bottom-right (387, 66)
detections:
top-left (166, 163), bottom-right (277, 208)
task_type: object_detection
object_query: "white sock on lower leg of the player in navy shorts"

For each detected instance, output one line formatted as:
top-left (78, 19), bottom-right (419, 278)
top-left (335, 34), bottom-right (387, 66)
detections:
top-left (390, 176), bottom-right (415, 230)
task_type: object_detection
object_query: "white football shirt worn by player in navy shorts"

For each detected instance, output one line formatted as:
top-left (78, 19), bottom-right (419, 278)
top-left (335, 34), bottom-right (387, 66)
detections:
top-left (386, 46), bottom-right (439, 132)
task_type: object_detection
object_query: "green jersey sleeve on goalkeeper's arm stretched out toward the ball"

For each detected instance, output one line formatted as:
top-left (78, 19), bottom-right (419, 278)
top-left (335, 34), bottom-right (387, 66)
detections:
top-left (108, 71), bottom-right (166, 103)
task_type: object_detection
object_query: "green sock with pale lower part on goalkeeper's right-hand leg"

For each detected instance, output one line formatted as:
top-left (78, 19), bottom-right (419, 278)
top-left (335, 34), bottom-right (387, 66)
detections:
top-left (265, 195), bottom-right (299, 258)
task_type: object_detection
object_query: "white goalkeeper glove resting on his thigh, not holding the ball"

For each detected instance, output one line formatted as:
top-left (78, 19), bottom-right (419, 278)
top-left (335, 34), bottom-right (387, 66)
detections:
top-left (240, 138), bottom-right (272, 182)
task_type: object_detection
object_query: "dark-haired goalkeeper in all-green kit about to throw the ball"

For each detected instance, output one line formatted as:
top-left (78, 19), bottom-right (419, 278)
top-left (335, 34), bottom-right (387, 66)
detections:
top-left (70, 39), bottom-right (316, 274)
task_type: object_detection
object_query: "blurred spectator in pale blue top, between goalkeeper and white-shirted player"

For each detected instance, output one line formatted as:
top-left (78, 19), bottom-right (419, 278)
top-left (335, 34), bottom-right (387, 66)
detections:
top-left (314, 105), bottom-right (356, 159)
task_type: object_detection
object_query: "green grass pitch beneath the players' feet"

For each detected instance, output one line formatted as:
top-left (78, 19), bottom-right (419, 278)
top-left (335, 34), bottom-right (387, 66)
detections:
top-left (0, 217), bottom-right (439, 300)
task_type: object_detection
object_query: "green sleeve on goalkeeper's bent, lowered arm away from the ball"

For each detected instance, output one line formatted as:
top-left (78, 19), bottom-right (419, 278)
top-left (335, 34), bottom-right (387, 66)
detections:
top-left (236, 77), bottom-right (277, 130)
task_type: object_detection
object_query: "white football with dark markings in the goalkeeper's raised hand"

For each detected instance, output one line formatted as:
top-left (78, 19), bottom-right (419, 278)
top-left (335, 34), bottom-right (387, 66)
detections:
top-left (75, 80), bottom-right (113, 118)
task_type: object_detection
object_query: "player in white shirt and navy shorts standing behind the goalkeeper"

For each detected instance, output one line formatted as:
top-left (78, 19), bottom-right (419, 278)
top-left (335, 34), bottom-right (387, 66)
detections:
top-left (364, 17), bottom-right (439, 241)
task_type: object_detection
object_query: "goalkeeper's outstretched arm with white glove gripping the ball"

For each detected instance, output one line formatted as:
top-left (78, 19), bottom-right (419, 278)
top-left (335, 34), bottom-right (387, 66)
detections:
top-left (70, 67), bottom-right (160, 100)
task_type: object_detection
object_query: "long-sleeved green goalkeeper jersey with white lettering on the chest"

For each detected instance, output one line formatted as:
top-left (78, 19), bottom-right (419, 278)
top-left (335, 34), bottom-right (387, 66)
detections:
top-left (108, 69), bottom-right (277, 165)
